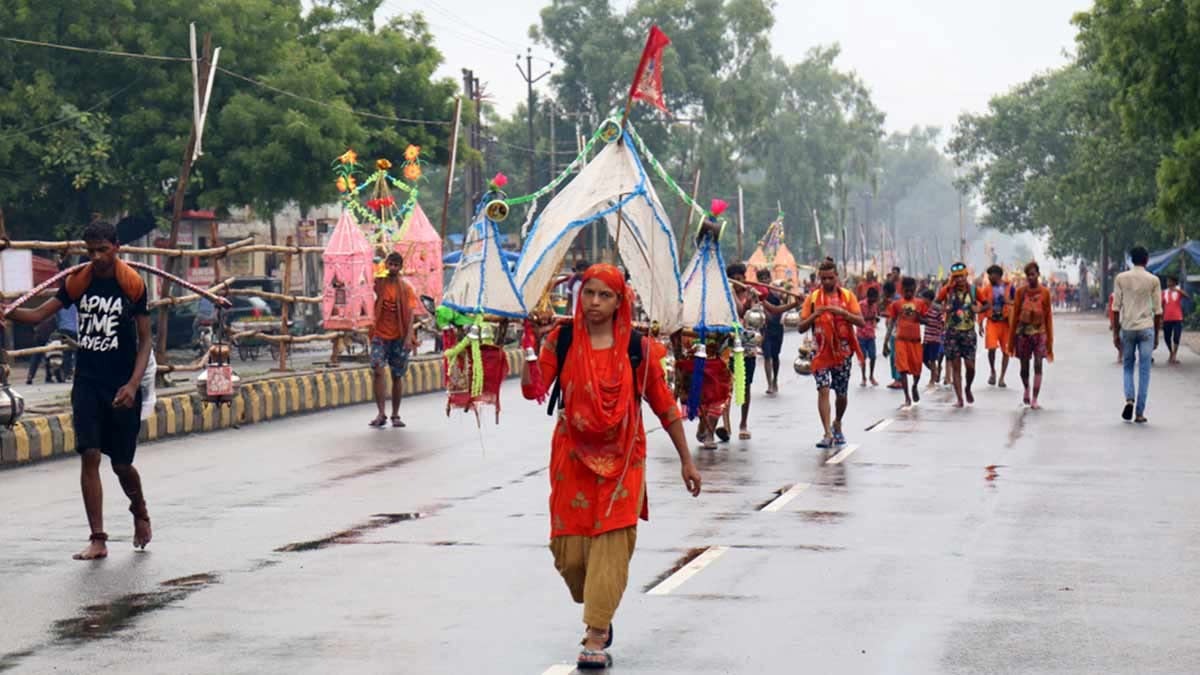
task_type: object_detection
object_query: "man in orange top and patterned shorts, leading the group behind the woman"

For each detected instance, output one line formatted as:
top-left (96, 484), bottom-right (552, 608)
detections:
top-left (800, 258), bottom-right (865, 449)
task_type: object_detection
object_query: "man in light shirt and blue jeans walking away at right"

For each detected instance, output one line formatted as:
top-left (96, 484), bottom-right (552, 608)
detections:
top-left (1112, 246), bottom-right (1163, 424)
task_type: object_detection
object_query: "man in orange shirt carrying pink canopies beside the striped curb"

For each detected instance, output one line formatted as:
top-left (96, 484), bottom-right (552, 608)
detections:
top-left (371, 251), bottom-right (420, 428)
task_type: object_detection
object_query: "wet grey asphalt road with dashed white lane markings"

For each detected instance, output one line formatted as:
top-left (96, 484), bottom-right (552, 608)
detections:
top-left (0, 317), bottom-right (1200, 675)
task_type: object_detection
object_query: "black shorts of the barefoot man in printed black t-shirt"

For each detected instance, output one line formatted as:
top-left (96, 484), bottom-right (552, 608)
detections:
top-left (71, 378), bottom-right (142, 465)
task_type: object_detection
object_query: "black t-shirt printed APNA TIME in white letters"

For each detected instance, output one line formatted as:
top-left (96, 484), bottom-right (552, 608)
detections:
top-left (58, 277), bottom-right (150, 389)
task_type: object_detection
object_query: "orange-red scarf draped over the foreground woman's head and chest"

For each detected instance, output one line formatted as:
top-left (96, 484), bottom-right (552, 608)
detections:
top-left (558, 264), bottom-right (641, 478)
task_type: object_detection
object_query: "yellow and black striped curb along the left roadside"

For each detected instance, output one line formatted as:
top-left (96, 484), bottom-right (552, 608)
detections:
top-left (0, 350), bottom-right (521, 468)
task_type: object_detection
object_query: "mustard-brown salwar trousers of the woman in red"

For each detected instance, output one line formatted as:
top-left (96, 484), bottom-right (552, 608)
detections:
top-left (550, 527), bottom-right (637, 631)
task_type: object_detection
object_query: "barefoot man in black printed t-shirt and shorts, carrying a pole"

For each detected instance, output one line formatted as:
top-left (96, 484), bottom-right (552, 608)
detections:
top-left (7, 223), bottom-right (151, 560)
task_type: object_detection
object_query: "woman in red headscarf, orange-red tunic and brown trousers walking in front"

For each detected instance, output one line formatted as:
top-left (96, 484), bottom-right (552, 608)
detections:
top-left (521, 264), bottom-right (701, 669)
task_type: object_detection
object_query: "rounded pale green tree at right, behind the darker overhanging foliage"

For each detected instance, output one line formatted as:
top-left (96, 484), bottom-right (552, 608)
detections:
top-left (950, 66), bottom-right (1160, 259)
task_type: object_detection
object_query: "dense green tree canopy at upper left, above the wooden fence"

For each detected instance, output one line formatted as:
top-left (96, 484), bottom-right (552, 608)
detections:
top-left (0, 0), bottom-right (455, 235)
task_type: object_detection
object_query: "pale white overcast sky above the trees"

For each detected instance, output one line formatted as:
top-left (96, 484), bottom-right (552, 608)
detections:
top-left (382, 0), bottom-right (1091, 131)
